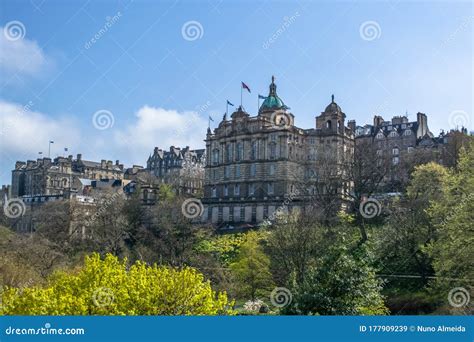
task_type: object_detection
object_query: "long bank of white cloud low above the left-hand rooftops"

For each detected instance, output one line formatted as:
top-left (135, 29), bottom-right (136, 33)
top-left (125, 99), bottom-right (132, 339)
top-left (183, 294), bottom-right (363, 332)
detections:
top-left (0, 99), bottom-right (207, 183)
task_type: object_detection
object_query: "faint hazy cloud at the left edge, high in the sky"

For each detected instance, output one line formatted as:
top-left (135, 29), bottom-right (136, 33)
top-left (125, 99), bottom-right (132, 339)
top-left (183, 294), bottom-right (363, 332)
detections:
top-left (0, 27), bottom-right (49, 76)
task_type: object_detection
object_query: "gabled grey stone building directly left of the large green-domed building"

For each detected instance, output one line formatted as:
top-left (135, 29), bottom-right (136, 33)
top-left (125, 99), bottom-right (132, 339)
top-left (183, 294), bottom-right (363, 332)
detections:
top-left (146, 146), bottom-right (205, 194)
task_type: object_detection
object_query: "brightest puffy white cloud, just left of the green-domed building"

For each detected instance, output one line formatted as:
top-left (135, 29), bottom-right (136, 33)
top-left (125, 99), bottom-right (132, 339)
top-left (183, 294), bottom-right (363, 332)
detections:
top-left (115, 106), bottom-right (207, 164)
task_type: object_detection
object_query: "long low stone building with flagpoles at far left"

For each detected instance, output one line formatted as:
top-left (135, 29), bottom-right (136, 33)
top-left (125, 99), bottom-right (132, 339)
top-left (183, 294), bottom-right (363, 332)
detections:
top-left (11, 154), bottom-right (124, 197)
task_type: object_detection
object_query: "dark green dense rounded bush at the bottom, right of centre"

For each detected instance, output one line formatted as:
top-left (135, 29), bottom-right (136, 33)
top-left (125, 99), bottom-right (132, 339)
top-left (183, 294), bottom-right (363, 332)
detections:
top-left (282, 244), bottom-right (388, 315)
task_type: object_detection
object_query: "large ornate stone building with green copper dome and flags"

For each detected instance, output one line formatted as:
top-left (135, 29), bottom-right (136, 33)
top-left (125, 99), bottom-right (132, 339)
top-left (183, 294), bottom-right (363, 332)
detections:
top-left (201, 77), bottom-right (354, 225)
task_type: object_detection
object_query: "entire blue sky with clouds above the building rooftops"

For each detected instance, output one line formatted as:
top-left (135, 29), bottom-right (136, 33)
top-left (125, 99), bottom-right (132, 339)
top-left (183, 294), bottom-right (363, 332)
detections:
top-left (0, 0), bottom-right (474, 184)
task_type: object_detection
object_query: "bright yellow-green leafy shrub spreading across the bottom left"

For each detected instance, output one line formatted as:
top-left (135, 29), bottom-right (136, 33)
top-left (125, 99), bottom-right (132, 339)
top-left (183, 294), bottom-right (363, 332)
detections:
top-left (2, 254), bottom-right (233, 315)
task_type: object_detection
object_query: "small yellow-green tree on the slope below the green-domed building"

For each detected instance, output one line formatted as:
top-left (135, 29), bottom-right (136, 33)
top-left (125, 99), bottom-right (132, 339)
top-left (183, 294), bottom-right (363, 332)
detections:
top-left (230, 232), bottom-right (273, 301)
